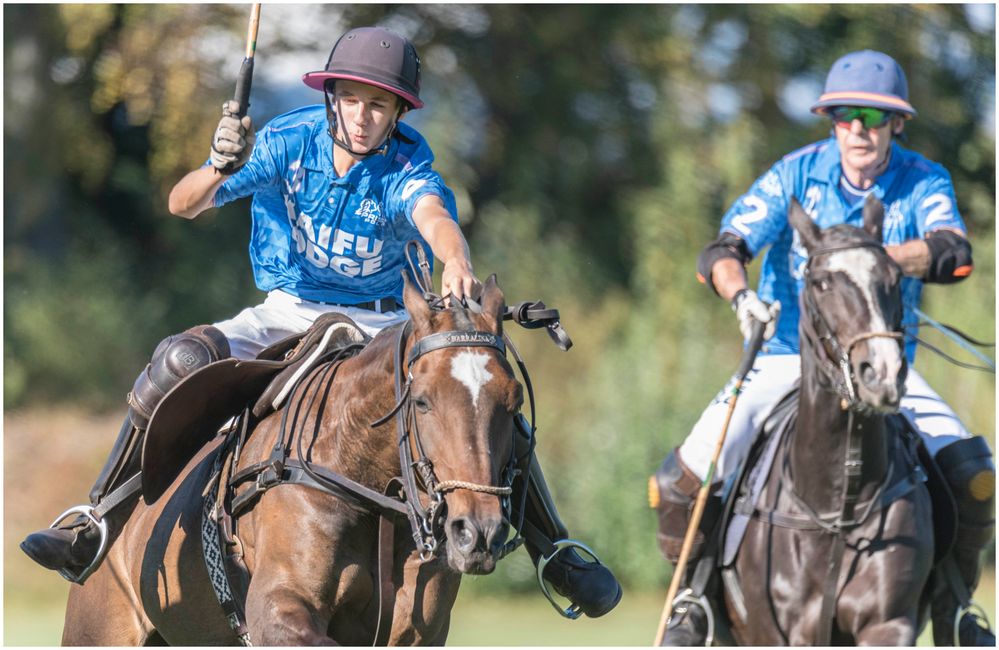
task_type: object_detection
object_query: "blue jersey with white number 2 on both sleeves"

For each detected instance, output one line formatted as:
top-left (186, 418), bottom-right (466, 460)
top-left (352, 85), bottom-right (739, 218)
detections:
top-left (720, 138), bottom-right (967, 363)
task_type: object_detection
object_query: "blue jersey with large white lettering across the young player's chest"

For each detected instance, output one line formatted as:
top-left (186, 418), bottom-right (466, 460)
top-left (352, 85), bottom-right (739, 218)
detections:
top-left (215, 105), bottom-right (458, 304)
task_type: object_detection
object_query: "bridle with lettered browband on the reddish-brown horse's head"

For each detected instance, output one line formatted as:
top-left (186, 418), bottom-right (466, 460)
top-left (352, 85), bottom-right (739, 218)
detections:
top-left (372, 321), bottom-right (519, 560)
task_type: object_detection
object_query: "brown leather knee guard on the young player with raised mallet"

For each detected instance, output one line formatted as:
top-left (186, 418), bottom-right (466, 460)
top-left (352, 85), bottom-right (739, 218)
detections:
top-left (128, 325), bottom-right (229, 429)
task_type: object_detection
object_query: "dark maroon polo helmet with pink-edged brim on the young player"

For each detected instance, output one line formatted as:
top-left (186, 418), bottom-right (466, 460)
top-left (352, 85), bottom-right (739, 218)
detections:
top-left (302, 27), bottom-right (423, 108)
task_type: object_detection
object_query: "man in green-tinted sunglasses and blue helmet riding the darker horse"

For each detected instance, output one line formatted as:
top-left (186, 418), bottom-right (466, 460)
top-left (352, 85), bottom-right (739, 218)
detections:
top-left (655, 50), bottom-right (995, 645)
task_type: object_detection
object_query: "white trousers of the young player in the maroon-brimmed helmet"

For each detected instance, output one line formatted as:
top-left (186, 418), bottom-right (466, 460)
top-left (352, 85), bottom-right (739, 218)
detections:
top-left (213, 289), bottom-right (409, 359)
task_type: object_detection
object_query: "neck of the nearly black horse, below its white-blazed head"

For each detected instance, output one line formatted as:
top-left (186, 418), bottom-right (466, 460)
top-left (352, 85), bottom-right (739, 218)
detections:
top-left (788, 345), bottom-right (887, 512)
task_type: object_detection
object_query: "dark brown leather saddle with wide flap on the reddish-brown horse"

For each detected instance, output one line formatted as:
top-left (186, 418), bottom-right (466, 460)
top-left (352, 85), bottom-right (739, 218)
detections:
top-left (142, 312), bottom-right (370, 504)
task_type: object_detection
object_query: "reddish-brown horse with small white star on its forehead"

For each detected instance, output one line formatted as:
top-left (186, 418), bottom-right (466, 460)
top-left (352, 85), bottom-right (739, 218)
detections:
top-left (63, 277), bottom-right (523, 645)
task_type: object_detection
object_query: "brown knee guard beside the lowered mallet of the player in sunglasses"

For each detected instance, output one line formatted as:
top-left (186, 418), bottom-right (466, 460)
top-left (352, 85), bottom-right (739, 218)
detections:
top-left (649, 449), bottom-right (721, 563)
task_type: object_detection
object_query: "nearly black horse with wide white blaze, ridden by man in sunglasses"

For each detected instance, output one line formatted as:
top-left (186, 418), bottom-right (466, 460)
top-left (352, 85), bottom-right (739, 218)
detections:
top-left (723, 199), bottom-right (934, 646)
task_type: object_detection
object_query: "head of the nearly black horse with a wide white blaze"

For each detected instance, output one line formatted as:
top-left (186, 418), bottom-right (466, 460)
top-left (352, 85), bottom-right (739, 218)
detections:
top-left (788, 194), bottom-right (907, 413)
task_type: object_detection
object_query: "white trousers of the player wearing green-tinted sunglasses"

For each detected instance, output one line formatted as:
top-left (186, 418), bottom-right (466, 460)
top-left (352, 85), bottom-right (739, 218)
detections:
top-left (680, 354), bottom-right (971, 482)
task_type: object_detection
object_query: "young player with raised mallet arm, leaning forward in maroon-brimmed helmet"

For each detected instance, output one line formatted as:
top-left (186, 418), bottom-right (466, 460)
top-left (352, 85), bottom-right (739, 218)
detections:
top-left (21, 27), bottom-right (621, 617)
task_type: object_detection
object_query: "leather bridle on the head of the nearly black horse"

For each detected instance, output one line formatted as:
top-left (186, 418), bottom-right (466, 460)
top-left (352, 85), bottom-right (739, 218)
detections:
top-left (804, 242), bottom-right (903, 409)
